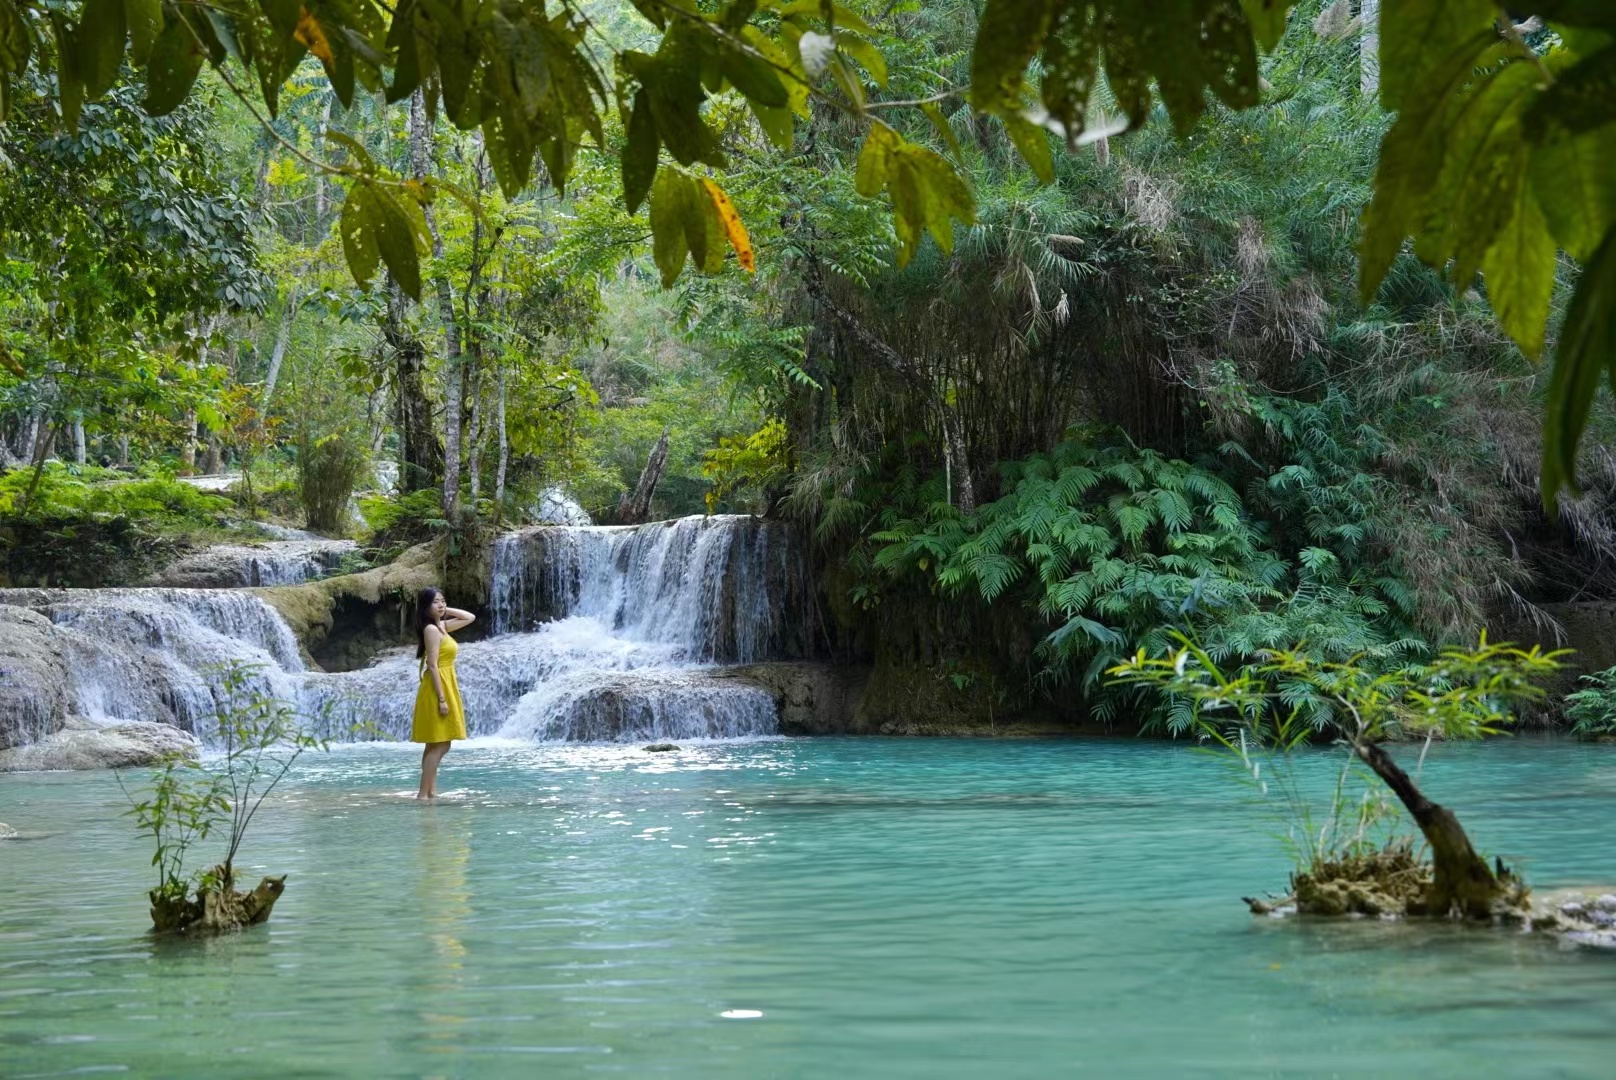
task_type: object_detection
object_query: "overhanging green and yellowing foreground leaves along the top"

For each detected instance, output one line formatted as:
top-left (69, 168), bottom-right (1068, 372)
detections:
top-left (0, 0), bottom-right (1616, 501)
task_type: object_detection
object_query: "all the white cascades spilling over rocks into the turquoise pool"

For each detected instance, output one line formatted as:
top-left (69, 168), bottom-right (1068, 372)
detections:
top-left (0, 517), bottom-right (800, 740)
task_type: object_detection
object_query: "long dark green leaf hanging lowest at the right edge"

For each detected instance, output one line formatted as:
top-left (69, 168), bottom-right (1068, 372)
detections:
top-left (1542, 233), bottom-right (1616, 513)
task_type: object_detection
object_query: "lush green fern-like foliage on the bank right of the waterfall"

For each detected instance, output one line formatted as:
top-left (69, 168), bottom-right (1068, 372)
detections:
top-left (869, 437), bottom-right (1429, 734)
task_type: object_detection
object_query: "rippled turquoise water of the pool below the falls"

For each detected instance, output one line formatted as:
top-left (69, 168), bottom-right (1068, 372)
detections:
top-left (0, 739), bottom-right (1616, 1080)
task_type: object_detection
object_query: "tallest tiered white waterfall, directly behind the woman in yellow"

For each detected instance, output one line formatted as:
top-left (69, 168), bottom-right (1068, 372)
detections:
top-left (301, 516), bottom-right (802, 742)
